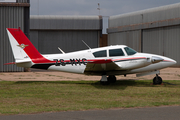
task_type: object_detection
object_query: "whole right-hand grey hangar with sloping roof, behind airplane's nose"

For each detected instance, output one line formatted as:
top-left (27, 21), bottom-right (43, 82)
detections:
top-left (107, 3), bottom-right (180, 67)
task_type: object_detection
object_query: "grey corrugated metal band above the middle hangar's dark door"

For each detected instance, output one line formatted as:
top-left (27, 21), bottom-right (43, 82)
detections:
top-left (30, 15), bottom-right (102, 30)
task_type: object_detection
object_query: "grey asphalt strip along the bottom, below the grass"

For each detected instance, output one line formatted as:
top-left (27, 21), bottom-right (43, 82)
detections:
top-left (0, 106), bottom-right (180, 120)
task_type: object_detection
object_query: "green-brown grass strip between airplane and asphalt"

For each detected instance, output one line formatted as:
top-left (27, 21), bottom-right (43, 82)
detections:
top-left (0, 80), bottom-right (180, 115)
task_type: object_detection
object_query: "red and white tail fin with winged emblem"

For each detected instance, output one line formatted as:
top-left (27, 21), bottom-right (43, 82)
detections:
top-left (7, 28), bottom-right (52, 63)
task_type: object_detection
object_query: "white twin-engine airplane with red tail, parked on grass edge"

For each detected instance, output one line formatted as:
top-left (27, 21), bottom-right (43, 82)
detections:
top-left (7, 28), bottom-right (176, 84)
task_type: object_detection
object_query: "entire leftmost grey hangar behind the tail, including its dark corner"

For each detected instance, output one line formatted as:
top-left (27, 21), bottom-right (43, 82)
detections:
top-left (0, 0), bottom-right (30, 72)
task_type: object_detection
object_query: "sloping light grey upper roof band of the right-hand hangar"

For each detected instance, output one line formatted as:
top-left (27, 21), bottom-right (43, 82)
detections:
top-left (109, 3), bottom-right (180, 27)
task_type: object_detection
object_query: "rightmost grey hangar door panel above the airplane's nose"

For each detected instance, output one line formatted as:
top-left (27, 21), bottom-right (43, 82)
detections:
top-left (142, 26), bottom-right (180, 67)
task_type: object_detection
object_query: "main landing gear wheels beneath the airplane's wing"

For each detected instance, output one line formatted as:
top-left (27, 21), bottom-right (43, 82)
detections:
top-left (100, 75), bottom-right (116, 85)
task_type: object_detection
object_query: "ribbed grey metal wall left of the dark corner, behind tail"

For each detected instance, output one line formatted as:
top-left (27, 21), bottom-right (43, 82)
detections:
top-left (0, 0), bottom-right (29, 72)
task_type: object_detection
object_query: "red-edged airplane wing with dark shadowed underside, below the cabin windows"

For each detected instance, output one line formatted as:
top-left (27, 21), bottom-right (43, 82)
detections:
top-left (84, 59), bottom-right (120, 72)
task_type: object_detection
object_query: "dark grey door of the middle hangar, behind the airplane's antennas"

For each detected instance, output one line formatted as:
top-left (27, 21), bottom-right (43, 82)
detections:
top-left (30, 30), bottom-right (99, 54)
